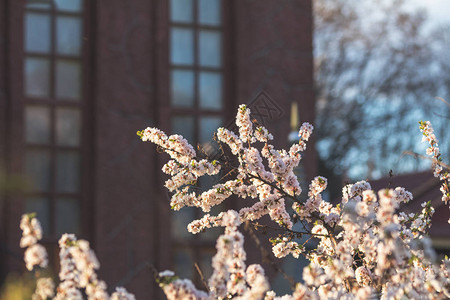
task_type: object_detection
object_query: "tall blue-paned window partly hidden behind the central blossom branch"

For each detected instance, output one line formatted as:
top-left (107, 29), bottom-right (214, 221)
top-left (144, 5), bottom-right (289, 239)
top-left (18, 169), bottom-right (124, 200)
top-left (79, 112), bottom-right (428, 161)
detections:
top-left (170, 0), bottom-right (224, 278)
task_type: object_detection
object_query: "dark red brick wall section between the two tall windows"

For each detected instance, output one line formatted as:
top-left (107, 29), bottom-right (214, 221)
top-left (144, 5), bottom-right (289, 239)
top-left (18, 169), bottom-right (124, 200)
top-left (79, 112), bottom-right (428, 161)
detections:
top-left (93, 0), bottom-right (158, 299)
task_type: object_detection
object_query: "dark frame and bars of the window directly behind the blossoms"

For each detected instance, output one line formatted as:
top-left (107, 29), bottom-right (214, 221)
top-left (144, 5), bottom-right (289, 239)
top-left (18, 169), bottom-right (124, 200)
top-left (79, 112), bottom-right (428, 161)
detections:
top-left (166, 0), bottom-right (236, 284)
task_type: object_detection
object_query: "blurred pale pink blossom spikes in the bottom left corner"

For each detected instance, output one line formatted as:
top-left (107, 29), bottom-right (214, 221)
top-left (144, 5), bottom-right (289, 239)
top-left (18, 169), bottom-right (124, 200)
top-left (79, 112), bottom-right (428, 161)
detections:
top-left (20, 214), bottom-right (135, 300)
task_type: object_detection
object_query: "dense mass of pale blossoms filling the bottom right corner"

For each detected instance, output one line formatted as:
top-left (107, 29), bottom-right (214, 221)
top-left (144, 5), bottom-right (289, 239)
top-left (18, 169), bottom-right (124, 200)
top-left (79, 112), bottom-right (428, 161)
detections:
top-left (288, 183), bottom-right (450, 299)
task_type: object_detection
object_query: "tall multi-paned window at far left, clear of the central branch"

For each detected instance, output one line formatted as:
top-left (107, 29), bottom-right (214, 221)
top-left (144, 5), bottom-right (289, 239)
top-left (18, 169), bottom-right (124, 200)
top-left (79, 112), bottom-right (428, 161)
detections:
top-left (23, 0), bottom-right (85, 238)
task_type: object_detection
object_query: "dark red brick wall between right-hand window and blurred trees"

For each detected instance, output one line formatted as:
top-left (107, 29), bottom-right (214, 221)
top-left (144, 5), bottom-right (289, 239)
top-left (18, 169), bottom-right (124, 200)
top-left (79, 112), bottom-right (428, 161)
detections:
top-left (233, 0), bottom-right (317, 179)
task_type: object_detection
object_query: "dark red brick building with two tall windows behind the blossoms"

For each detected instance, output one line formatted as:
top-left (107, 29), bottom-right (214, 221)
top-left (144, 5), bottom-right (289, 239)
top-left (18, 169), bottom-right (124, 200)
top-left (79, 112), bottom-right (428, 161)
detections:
top-left (0, 0), bottom-right (316, 299)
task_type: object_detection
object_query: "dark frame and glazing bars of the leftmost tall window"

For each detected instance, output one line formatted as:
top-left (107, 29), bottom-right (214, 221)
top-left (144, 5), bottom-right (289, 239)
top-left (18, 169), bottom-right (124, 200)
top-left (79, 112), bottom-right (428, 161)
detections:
top-left (18, 0), bottom-right (95, 245)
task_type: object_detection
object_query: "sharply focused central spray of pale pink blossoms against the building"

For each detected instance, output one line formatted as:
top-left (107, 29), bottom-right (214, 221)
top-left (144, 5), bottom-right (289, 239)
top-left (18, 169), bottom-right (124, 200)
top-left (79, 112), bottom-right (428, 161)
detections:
top-left (138, 105), bottom-right (313, 233)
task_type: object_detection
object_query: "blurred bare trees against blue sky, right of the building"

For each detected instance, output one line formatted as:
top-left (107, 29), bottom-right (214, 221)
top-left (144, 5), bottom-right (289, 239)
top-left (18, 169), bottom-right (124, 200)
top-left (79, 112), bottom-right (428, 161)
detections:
top-left (314, 0), bottom-right (450, 197)
